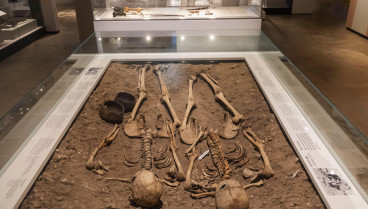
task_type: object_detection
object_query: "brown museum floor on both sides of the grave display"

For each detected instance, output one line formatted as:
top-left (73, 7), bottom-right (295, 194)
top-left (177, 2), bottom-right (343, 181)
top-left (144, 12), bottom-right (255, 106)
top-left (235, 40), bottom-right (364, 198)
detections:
top-left (0, 0), bottom-right (368, 136)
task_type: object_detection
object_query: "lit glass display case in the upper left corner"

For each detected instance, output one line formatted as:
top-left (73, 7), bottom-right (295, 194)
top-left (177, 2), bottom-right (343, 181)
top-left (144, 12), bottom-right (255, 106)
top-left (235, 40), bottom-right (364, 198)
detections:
top-left (0, 0), bottom-right (38, 42)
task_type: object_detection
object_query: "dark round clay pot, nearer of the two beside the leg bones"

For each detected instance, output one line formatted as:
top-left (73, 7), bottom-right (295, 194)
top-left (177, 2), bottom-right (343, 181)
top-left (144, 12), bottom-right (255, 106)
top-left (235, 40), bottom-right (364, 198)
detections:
top-left (100, 100), bottom-right (124, 123)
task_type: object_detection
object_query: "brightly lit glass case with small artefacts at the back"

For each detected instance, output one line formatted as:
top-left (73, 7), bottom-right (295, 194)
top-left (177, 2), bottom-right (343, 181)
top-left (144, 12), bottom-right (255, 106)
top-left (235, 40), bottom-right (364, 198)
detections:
top-left (92, 0), bottom-right (262, 20)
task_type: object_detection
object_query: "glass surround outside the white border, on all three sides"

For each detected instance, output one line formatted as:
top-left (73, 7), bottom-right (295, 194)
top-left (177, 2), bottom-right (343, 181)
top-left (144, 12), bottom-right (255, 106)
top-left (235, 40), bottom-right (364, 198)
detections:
top-left (0, 30), bottom-right (368, 200)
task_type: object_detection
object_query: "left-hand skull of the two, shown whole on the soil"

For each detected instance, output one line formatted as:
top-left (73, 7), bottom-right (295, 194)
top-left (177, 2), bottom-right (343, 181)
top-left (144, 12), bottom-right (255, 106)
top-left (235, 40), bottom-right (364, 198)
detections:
top-left (131, 170), bottom-right (163, 208)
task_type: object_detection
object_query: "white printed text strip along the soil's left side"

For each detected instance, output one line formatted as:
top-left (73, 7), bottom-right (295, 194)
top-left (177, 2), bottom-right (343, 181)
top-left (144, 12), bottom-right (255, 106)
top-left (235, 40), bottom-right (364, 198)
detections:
top-left (0, 54), bottom-right (108, 209)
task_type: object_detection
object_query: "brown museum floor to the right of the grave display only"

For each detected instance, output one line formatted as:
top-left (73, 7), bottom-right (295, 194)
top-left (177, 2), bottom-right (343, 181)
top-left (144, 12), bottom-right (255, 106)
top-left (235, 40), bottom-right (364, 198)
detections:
top-left (262, 0), bottom-right (368, 136)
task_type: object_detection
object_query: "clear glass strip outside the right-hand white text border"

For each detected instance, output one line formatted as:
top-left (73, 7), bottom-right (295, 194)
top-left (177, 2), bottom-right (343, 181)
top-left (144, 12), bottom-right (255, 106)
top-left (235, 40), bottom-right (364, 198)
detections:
top-left (261, 51), bottom-right (368, 198)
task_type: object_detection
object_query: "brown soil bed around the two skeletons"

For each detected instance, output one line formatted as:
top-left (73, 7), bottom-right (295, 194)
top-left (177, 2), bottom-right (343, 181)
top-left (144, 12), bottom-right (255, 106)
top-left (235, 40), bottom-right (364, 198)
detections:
top-left (21, 62), bottom-right (325, 209)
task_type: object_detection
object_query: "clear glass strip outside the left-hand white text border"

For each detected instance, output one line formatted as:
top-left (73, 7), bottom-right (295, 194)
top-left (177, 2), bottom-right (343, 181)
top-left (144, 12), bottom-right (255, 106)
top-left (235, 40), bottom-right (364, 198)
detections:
top-left (0, 57), bottom-right (96, 175)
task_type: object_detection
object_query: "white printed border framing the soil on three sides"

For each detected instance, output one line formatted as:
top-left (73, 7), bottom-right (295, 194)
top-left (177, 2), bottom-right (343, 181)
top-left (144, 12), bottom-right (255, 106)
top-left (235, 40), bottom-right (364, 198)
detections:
top-left (0, 52), bottom-right (368, 209)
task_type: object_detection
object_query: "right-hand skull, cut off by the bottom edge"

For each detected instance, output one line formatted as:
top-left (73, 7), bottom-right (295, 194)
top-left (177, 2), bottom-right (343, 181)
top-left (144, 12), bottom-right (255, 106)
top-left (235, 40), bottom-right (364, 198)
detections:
top-left (215, 179), bottom-right (249, 209)
